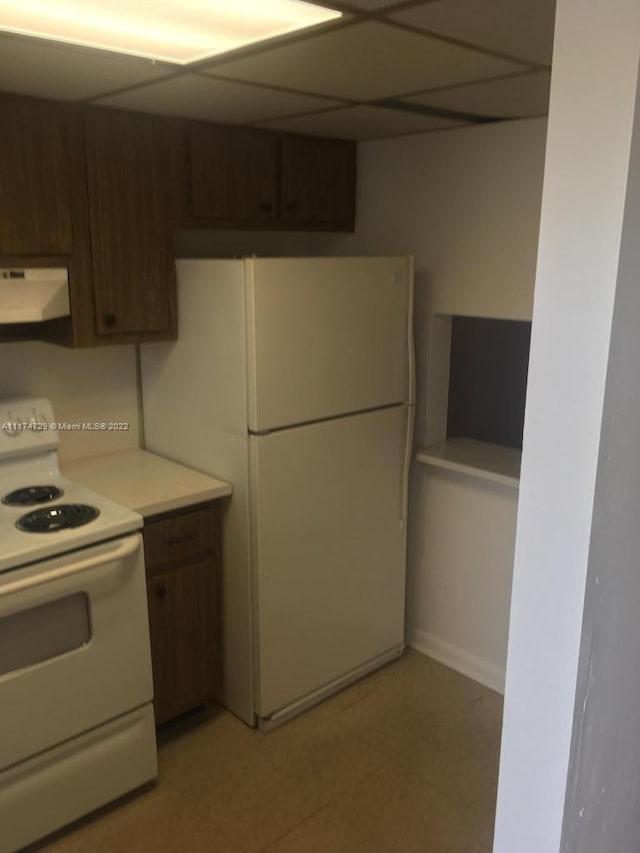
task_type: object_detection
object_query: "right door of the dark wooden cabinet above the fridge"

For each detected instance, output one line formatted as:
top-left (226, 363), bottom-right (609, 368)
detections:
top-left (281, 135), bottom-right (356, 231)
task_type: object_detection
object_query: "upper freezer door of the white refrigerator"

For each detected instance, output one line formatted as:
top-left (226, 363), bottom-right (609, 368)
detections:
top-left (245, 251), bottom-right (413, 432)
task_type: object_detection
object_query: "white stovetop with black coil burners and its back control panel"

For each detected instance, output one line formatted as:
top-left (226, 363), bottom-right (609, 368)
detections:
top-left (0, 400), bottom-right (142, 573)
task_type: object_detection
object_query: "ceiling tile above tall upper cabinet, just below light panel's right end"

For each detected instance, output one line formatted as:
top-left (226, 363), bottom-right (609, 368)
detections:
top-left (96, 74), bottom-right (338, 124)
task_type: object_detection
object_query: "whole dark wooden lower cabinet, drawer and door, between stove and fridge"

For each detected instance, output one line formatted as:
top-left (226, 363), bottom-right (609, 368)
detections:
top-left (144, 504), bottom-right (221, 725)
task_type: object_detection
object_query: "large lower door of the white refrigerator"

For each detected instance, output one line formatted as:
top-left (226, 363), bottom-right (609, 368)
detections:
top-left (250, 406), bottom-right (408, 717)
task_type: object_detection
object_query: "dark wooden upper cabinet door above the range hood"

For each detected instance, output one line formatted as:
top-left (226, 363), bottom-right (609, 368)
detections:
top-left (0, 95), bottom-right (72, 255)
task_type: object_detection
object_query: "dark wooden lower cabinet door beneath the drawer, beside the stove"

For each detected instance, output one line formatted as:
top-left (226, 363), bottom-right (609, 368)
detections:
top-left (147, 560), bottom-right (219, 724)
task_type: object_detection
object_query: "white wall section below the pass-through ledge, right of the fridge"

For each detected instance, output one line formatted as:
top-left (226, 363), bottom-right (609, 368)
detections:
top-left (407, 466), bottom-right (517, 691)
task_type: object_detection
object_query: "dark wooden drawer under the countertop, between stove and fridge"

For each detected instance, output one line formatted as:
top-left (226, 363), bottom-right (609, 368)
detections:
top-left (144, 506), bottom-right (216, 572)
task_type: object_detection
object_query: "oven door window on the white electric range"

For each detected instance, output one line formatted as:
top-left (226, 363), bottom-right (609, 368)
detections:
top-left (0, 592), bottom-right (91, 676)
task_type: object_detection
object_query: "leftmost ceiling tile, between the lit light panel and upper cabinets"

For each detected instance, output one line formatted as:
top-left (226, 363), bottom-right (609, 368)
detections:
top-left (0, 36), bottom-right (172, 101)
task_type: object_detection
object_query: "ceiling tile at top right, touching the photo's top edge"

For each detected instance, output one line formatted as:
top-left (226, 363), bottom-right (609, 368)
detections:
top-left (392, 0), bottom-right (555, 65)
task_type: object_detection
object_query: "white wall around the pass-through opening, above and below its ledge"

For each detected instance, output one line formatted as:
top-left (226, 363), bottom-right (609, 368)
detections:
top-left (331, 119), bottom-right (546, 689)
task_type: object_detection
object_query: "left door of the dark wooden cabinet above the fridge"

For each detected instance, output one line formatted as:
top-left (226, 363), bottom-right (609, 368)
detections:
top-left (188, 122), bottom-right (278, 223)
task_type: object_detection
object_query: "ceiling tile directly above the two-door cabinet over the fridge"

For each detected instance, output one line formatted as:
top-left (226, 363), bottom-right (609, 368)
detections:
top-left (261, 106), bottom-right (468, 139)
